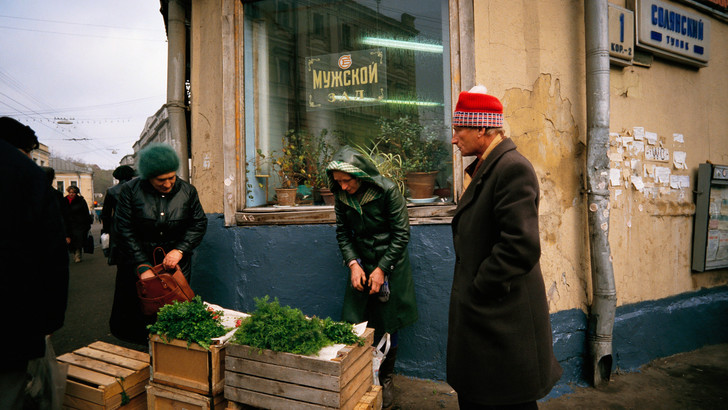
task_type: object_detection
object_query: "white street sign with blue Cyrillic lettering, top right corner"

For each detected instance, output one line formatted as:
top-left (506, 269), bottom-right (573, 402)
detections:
top-left (635, 0), bottom-right (710, 67)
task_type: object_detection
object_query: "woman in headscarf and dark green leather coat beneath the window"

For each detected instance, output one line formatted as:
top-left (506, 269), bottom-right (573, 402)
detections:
top-left (326, 146), bottom-right (417, 407)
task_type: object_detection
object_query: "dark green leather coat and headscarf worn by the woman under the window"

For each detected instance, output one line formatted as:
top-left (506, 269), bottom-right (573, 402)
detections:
top-left (328, 147), bottom-right (417, 333)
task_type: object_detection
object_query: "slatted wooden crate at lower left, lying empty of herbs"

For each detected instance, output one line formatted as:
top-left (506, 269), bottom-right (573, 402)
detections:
top-left (58, 342), bottom-right (149, 410)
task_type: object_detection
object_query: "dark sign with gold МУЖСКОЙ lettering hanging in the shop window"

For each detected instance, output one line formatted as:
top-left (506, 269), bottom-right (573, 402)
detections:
top-left (306, 48), bottom-right (387, 111)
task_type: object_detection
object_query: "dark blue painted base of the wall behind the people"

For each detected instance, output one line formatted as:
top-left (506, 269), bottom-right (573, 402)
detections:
top-left (191, 214), bottom-right (728, 395)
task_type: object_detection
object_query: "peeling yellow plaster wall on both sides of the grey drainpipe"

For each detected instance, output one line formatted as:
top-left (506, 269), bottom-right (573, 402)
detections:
top-left (474, 0), bottom-right (728, 312)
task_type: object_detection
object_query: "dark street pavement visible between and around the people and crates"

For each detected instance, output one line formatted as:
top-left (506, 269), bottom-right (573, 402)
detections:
top-left (52, 223), bottom-right (728, 410)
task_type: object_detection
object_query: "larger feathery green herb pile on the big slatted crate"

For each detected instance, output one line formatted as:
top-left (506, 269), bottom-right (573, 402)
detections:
top-left (232, 296), bottom-right (364, 355)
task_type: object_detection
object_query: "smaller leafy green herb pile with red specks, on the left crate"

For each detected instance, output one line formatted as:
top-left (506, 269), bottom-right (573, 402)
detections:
top-left (147, 296), bottom-right (226, 349)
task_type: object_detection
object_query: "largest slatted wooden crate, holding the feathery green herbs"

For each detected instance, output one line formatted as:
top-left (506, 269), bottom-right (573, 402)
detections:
top-left (225, 328), bottom-right (374, 409)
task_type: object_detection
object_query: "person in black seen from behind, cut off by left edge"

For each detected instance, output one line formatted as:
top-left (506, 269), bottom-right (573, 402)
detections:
top-left (0, 117), bottom-right (68, 410)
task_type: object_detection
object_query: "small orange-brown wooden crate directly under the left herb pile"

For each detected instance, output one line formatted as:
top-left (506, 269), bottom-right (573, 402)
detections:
top-left (149, 335), bottom-right (226, 396)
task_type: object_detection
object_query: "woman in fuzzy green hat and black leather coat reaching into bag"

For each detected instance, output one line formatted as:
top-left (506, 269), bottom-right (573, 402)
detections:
top-left (109, 144), bottom-right (207, 344)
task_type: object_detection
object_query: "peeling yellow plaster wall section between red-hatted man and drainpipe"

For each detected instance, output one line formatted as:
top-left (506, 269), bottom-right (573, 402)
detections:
top-left (474, 1), bottom-right (591, 312)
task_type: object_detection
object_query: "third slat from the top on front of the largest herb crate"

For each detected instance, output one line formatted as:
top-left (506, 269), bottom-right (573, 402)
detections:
top-left (225, 372), bottom-right (341, 407)
